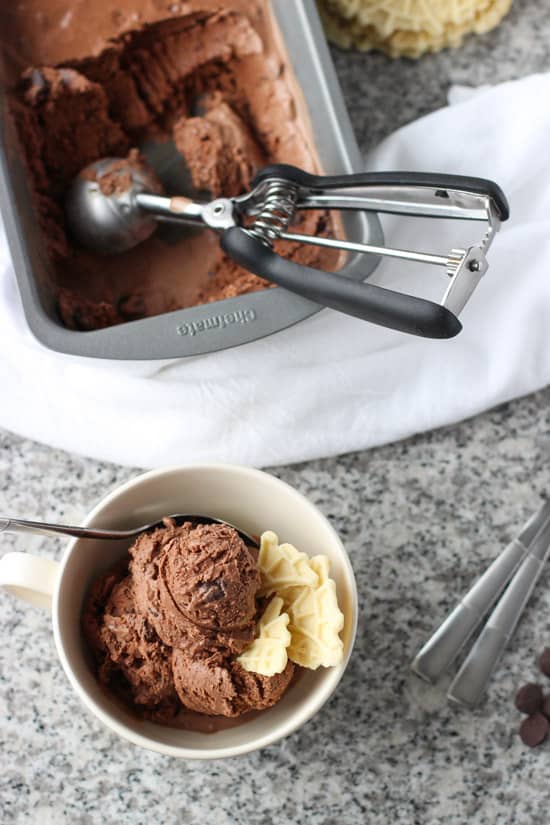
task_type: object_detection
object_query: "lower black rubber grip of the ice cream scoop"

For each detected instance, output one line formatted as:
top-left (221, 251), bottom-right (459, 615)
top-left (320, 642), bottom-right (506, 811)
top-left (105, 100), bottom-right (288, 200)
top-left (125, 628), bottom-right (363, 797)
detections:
top-left (221, 226), bottom-right (462, 338)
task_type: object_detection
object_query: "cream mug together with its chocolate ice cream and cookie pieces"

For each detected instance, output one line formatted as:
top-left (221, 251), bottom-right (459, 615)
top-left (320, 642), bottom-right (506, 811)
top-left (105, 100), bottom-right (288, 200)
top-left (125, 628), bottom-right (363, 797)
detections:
top-left (0, 464), bottom-right (357, 759)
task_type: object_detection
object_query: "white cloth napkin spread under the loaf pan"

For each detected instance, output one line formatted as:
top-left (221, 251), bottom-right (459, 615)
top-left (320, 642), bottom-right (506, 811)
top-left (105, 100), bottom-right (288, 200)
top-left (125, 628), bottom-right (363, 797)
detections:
top-left (0, 74), bottom-right (550, 466)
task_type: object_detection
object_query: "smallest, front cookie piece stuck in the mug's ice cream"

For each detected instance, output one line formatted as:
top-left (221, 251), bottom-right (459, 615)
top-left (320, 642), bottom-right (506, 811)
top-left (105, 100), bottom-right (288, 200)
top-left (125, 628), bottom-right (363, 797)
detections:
top-left (237, 596), bottom-right (291, 676)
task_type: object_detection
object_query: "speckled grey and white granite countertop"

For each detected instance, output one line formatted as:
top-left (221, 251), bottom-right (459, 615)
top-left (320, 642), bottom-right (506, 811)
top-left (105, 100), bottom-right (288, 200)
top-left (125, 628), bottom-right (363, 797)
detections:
top-left (0, 0), bottom-right (550, 825)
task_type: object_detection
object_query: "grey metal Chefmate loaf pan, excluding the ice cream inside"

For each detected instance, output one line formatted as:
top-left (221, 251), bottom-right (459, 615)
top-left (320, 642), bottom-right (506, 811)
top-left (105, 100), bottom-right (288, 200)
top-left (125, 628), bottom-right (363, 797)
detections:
top-left (0, 0), bottom-right (382, 360)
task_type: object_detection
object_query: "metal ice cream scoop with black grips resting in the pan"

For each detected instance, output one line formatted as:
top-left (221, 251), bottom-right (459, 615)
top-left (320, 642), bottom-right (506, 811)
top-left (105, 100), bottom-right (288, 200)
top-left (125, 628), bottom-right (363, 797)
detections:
top-left (65, 154), bottom-right (509, 338)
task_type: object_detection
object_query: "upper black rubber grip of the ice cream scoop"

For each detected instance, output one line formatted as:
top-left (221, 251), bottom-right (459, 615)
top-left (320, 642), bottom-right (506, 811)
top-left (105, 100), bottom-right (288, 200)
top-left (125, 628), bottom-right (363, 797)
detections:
top-left (252, 163), bottom-right (510, 221)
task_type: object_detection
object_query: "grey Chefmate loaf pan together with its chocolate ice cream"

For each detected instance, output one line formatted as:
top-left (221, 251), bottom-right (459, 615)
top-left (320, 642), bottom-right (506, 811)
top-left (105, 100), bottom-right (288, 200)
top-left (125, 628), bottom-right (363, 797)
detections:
top-left (0, 0), bottom-right (380, 358)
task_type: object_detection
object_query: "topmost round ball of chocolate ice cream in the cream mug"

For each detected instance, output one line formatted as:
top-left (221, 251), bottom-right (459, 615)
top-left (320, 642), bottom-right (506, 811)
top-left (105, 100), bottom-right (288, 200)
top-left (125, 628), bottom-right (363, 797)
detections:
top-left (129, 519), bottom-right (260, 657)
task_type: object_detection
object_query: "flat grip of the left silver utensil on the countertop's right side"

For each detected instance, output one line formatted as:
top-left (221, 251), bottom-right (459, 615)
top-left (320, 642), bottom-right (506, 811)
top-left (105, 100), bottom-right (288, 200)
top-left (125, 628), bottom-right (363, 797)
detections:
top-left (411, 539), bottom-right (527, 682)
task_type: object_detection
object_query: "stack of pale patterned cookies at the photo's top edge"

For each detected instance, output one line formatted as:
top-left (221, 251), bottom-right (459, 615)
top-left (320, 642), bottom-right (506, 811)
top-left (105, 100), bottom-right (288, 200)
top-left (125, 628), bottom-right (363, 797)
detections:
top-left (317, 0), bottom-right (512, 58)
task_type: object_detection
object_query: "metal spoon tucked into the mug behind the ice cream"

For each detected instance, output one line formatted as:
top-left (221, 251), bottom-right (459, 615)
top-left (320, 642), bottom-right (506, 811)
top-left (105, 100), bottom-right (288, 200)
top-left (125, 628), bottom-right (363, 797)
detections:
top-left (0, 513), bottom-right (258, 547)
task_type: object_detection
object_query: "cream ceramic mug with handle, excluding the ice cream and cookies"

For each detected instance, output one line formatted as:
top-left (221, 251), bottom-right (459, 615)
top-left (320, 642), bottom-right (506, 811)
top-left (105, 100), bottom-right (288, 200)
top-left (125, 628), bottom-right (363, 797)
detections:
top-left (0, 464), bottom-right (357, 759)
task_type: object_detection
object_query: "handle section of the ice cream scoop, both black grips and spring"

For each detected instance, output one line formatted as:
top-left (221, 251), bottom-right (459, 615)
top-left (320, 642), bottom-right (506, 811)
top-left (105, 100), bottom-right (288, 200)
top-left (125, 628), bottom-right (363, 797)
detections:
top-left (232, 164), bottom-right (509, 338)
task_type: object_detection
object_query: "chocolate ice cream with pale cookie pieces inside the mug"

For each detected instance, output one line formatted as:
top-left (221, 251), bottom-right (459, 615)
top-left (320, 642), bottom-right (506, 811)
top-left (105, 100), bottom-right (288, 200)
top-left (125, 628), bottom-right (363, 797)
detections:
top-left (82, 519), bottom-right (343, 732)
